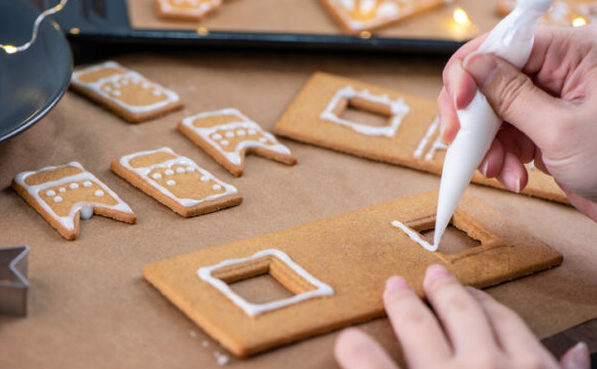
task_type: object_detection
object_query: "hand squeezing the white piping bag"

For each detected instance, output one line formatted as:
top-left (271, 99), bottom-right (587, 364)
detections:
top-left (438, 26), bottom-right (597, 221)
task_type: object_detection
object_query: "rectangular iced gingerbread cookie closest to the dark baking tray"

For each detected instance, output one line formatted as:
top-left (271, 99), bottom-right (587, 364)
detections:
top-left (70, 61), bottom-right (183, 123)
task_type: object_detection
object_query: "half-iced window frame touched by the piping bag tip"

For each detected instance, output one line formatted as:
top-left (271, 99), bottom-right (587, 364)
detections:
top-left (391, 209), bottom-right (510, 263)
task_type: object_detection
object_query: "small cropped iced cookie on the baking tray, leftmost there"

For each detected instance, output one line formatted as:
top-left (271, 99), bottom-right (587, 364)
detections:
top-left (155, 0), bottom-right (222, 21)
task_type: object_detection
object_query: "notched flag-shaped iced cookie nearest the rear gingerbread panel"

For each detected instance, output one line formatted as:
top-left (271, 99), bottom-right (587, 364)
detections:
top-left (178, 108), bottom-right (297, 177)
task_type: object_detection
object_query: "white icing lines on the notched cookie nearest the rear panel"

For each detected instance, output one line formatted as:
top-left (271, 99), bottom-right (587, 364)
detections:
top-left (182, 108), bottom-right (290, 165)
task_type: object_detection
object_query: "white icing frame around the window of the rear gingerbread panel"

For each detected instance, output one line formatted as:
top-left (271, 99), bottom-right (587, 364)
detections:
top-left (320, 86), bottom-right (410, 137)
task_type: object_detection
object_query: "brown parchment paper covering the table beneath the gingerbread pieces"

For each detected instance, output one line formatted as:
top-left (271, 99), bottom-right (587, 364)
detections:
top-left (0, 51), bottom-right (597, 369)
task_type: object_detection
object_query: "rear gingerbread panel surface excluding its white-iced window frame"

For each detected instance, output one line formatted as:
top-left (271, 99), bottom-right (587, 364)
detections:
top-left (273, 72), bottom-right (569, 204)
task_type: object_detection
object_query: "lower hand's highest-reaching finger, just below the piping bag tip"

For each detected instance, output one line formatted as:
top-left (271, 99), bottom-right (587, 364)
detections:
top-left (423, 264), bottom-right (497, 355)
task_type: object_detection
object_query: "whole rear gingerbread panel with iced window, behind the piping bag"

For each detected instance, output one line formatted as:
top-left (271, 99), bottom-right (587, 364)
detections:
top-left (274, 73), bottom-right (569, 204)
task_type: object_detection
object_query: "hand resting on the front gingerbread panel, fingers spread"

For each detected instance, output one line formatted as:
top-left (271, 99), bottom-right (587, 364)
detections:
top-left (335, 265), bottom-right (591, 369)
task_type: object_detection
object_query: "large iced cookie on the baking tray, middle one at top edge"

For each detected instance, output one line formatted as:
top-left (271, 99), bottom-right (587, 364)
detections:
top-left (321, 0), bottom-right (451, 34)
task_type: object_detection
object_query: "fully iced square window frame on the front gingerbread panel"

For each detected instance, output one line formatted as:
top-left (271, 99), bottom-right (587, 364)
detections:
top-left (197, 249), bottom-right (334, 317)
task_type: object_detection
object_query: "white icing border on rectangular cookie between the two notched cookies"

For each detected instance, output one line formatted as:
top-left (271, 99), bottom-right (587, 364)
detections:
top-left (120, 147), bottom-right (238, 207)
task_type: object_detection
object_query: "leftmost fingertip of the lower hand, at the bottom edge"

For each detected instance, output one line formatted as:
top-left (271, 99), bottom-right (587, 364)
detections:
top-left (334, 328), bottom-right (398, 369)
